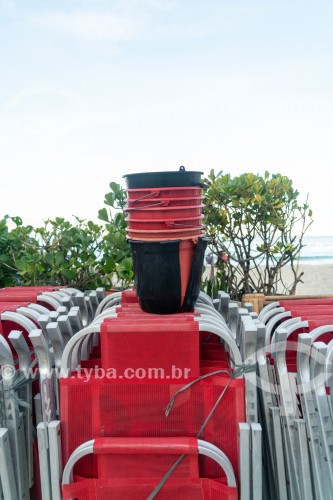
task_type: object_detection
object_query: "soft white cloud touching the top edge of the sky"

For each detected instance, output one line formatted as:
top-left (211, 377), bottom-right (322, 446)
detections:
top-left (37, 0), bottom-right (215, 42)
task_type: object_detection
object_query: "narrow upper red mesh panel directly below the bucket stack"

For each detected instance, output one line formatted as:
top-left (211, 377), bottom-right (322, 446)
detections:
top-left (100, 317), bottom-right (200, 378)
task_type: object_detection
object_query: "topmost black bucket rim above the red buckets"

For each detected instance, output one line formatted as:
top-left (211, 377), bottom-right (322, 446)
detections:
top-left (123, 167), bottom-right (203, 189)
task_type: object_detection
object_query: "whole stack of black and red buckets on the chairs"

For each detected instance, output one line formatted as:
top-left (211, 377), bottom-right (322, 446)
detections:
top-left (124, 167), bottom-right (209, 314)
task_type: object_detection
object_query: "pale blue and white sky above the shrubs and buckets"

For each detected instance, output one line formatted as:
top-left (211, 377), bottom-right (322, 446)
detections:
top-left (0, 0), bottom-right (333, 235)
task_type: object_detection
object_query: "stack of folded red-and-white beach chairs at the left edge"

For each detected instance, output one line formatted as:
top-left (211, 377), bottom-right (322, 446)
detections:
top-left (0, 287), bottom-right (105, 500)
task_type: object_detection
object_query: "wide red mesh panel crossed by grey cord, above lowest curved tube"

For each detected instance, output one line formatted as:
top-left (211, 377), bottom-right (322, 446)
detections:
top-left (60, 376), bottom-right (245, 477)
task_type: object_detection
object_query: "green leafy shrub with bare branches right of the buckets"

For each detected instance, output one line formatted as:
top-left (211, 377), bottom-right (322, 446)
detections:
top-left (204, 170), bottom-right (312, 300)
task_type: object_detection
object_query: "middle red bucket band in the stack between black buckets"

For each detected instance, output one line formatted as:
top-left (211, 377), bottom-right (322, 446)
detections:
top-left (125, 204), bottom-right (203, 221)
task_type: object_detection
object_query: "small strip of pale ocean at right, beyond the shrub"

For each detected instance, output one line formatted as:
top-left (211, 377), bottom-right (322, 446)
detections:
top-left (300, 236), bottom-right (333, 265)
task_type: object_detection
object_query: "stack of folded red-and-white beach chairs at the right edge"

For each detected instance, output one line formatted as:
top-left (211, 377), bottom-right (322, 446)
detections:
top-left (259, 298), bottom-right (333, 499)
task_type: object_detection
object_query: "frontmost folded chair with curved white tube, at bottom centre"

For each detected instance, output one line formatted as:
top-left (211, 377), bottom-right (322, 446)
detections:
top-left (62, 437), bottom-right (238, 500)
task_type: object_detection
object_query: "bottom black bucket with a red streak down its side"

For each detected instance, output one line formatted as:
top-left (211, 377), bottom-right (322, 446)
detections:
top-left (129, 237), bottom-right (209, 314)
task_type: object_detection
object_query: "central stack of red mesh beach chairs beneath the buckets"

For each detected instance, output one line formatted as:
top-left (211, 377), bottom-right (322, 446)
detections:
top-left (60, 291), bottom-right (245, 499)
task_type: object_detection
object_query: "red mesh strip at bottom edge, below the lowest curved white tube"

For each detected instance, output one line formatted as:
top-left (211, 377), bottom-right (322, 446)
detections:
top-left (63, 478), bottom-right (238, 500)
